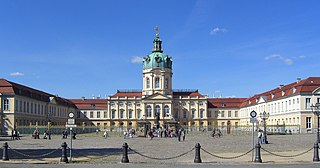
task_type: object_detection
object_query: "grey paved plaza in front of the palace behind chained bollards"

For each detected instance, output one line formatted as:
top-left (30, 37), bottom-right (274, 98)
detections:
top-left (0, 132), bottom-right (319, 167)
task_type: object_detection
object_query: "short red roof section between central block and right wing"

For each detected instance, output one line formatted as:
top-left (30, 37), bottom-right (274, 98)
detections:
top-left (208, 98), bottom-right (246, 108)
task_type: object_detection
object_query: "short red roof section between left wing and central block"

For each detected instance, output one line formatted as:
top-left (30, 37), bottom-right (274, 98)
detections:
top-left (69, 99), bottom-right (108, 109)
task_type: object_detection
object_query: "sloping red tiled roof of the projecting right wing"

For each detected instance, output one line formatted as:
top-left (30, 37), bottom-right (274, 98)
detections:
top-left (241, 77), bottom-right (320, 107)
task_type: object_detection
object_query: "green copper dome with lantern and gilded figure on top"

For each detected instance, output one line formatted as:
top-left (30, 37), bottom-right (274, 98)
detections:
top-left (142, 27), bottom-right (172, 69)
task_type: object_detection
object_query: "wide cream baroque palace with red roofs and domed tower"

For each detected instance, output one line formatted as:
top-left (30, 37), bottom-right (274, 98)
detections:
top-left (0, 29), bottom-right (320, 133)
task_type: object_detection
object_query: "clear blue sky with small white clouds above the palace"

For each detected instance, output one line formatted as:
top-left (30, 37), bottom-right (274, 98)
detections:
top-left (0, 0), bottom-right (320, 98)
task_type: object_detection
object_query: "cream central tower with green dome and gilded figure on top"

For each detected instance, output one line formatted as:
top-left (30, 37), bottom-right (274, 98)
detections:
top-left (142, 26), bottom-right (172, 97)
